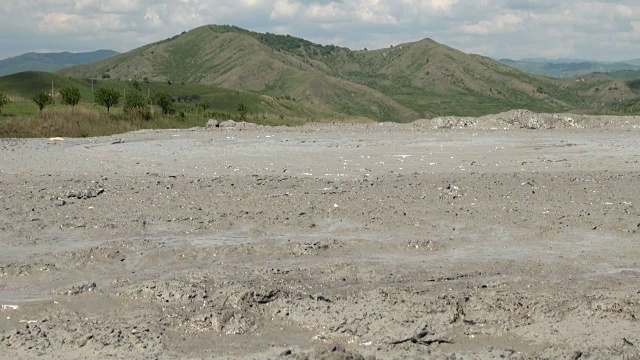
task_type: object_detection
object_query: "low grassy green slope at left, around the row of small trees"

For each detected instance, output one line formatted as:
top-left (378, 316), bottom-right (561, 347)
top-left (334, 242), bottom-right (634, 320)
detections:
top-left (0, 72), bottom-right (350, 137)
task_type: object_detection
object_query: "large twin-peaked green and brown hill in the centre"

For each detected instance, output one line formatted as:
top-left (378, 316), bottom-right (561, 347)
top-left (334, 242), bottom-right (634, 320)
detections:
top-left (59, 25), bottom-right (636, 121)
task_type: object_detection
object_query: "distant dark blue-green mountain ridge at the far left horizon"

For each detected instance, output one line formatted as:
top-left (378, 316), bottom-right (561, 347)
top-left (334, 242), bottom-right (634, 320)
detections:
top-left (0, 50), bottom-right (118, 76)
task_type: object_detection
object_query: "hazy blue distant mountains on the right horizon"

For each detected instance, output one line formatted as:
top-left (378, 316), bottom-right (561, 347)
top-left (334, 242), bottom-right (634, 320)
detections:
top-left (499, 58), bottom-right (639, 78)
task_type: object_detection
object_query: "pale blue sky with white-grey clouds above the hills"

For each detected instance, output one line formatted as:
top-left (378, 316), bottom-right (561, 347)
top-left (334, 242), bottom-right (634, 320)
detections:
top-left (0, 0), bottom-right (640, 61)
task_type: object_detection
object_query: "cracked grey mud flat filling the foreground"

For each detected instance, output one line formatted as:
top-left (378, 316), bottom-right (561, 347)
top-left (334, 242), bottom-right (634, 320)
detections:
top-left (0, 112), bottom-right (640, 359)
